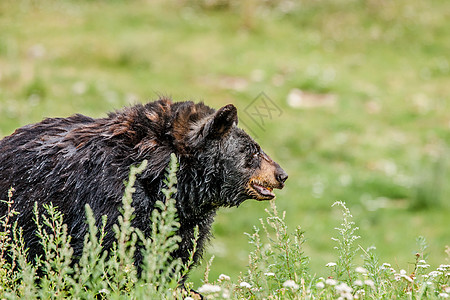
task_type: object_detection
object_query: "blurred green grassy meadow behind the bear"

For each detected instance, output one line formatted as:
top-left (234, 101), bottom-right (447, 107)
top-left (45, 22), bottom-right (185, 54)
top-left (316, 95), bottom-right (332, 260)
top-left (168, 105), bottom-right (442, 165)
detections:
top-left (0, 0), bottom-right (450, 284)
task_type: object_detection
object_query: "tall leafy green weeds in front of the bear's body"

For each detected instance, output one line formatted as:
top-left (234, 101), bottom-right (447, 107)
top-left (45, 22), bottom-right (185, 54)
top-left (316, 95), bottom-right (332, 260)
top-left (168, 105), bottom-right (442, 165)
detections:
top-left (0, 155), bottom-right (198, 299)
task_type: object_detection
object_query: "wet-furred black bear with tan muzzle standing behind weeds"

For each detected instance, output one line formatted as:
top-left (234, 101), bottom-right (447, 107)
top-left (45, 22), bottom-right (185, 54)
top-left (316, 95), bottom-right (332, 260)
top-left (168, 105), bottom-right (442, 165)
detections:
top-left (0, 99), bottom-right (288, 274)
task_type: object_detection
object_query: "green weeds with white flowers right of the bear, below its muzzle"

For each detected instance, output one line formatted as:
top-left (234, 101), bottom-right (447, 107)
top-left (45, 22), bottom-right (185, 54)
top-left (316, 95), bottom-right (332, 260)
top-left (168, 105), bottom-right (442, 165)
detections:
top-left (199, 201), bottom-right (450, 299)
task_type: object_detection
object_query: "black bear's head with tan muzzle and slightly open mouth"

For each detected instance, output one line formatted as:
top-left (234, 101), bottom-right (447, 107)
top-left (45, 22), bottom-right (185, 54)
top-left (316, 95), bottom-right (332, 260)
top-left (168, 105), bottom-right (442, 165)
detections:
top-left (175, 104), bottom-right (288, 206)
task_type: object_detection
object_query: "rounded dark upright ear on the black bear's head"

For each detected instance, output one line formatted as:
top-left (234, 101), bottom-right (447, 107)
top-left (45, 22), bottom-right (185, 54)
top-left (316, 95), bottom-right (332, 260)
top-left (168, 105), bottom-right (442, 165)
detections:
top-left (203, 104), bottom-right (238, 139)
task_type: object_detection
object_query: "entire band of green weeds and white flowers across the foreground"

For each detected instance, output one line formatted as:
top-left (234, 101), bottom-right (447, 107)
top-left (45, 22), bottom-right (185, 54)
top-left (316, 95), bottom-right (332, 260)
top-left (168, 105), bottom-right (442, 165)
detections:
top-left (0, 158), bottom-right (450, 299)
